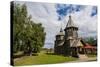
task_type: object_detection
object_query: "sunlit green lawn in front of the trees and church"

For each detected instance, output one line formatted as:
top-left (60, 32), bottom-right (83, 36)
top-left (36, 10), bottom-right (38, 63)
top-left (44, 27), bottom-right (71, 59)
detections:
top-left (14, 52), bottom-right (77, 66)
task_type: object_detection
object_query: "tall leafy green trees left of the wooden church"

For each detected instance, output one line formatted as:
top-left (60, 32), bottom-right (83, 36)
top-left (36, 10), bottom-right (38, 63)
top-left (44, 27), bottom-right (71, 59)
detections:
top-left (13, 4), bottom-right (46, 54)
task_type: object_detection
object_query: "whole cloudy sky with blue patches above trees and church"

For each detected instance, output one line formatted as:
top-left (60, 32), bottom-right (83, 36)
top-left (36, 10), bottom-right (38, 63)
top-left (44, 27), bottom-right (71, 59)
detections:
top-left (15, 1), bottom-right (97, 48)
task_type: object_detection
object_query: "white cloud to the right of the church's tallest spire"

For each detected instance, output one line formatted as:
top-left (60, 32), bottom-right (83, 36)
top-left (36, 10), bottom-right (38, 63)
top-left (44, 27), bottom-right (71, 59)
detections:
top-left (70, 6), bottom-right (97, 37)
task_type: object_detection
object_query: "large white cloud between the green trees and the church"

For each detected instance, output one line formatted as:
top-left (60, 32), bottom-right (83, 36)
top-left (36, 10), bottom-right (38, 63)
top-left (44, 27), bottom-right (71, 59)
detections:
top-left (23, 3), bottom-right (61, 47)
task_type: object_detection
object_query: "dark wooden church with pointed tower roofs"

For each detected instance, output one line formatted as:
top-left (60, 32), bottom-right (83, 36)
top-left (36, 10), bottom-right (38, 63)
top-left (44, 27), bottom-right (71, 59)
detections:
top-left (54, 16), bottom-right (85, 57)
